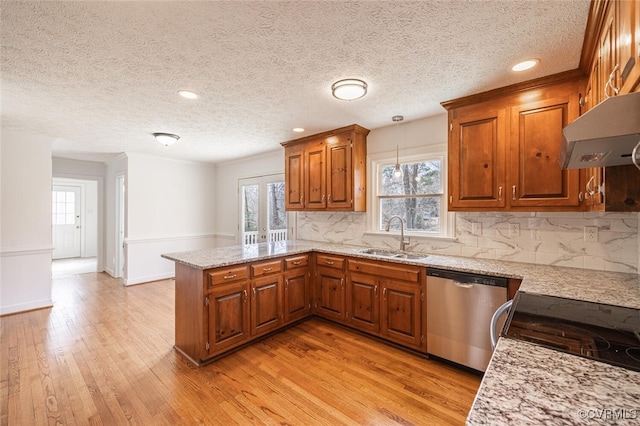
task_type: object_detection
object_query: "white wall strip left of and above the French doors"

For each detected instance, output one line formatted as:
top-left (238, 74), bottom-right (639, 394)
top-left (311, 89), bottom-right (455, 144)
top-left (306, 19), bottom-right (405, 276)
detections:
top-left (215, 148), bottom-right (284, 246)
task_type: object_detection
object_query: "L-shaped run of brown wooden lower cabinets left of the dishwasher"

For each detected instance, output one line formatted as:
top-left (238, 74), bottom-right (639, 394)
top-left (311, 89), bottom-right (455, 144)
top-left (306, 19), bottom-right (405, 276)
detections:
top-left (175, 253), bottom-right (426, 364)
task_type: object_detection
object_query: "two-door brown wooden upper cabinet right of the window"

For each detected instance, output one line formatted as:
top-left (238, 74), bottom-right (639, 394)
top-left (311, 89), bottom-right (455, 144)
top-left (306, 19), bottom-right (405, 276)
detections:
top-left (443, 73), bottom-right (583, 211)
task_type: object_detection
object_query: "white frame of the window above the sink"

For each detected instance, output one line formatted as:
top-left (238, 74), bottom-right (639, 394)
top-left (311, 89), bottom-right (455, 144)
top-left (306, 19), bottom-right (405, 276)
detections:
top-left (367, 144), bottom-right (455, 241)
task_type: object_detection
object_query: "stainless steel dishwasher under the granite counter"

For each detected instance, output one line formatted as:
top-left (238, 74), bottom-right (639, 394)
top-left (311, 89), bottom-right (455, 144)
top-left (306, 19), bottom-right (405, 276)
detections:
top-left (427, 268), bottom-right (507, 371)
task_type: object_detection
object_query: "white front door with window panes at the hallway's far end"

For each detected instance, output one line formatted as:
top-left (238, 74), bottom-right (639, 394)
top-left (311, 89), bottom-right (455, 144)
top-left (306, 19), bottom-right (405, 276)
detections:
top-left (51, 186), bottom-right (82, 259)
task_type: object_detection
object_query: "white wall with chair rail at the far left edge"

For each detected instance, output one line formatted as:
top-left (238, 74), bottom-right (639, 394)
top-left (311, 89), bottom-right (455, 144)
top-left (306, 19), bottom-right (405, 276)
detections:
top-left (0, 130), bottom-right (52, 315)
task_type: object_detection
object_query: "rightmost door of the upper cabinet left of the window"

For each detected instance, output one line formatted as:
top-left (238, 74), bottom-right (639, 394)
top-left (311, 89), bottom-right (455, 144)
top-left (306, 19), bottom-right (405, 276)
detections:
top-left (327, 133), bottom-right (353, 209)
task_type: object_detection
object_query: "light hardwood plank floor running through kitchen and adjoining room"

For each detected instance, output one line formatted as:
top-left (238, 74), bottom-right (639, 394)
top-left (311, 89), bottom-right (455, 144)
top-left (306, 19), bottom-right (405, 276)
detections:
top-left (0, 273), bottom-right (480, 426)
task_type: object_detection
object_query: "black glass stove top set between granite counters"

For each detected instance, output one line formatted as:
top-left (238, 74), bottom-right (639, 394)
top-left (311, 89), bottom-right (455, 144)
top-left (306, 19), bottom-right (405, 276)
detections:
top-left (501, 292), bottom-right (640, 371)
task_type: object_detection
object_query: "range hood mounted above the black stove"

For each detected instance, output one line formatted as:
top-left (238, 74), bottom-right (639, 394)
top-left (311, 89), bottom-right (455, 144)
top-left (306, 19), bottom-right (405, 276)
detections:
top-left (559, 92), bottom-right (640, 169)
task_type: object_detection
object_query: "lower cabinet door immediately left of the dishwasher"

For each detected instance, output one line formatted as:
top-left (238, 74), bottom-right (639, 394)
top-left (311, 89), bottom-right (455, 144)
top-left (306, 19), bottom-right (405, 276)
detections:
top-left (380, 280), bottom-right (425, 350)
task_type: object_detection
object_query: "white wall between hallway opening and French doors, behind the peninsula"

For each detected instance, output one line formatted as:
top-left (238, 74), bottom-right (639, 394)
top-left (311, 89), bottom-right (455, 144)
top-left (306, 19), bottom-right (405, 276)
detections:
top-left (125, 153), bottom-right (218, 285)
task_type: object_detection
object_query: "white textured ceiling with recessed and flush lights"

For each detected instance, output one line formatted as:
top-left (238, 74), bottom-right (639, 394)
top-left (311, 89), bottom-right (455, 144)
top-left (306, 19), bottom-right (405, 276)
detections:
top-left (0, 0), bottom-right (589, 162)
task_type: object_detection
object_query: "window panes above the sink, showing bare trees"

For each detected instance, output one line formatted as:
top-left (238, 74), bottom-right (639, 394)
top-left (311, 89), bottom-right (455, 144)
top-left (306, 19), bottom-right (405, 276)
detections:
top-left (373, 154), bottom-right (447, 237)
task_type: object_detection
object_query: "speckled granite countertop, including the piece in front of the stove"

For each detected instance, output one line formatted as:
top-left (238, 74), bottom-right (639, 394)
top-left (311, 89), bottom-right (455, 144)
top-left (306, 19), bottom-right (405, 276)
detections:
top-left (162, 241), bottom-right (640, 425)
